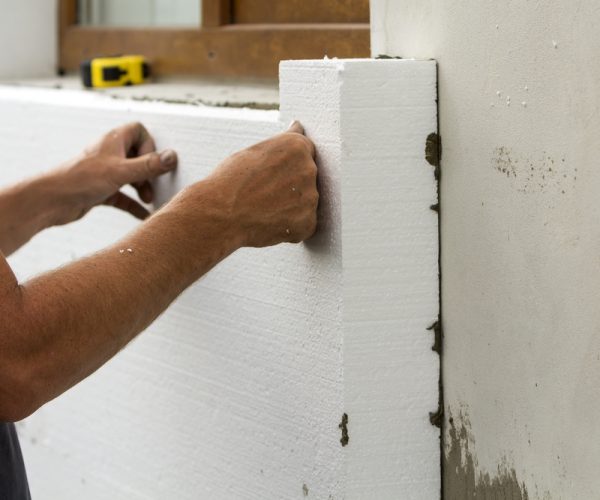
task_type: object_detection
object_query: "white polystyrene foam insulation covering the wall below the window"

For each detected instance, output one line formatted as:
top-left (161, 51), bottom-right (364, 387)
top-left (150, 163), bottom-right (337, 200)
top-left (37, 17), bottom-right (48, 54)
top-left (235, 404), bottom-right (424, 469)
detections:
top-left (0, 60), bottom-right (440, 500)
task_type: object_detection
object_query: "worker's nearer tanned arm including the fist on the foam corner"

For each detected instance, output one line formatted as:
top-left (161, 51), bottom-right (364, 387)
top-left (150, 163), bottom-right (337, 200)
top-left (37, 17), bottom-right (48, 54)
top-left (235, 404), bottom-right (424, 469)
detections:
top-left (0, 121), bottom-right (318, 421)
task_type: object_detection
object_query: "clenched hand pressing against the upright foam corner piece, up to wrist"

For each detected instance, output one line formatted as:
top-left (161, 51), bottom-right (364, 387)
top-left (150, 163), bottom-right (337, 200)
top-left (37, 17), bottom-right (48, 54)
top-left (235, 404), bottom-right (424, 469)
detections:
top-left (207, 122), bottom-right (319, 247)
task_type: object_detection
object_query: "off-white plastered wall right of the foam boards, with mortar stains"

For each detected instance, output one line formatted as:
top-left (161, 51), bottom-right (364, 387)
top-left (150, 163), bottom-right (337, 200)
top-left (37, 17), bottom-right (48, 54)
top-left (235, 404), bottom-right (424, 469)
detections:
top-left (371, 0), bottom-right (600, 500)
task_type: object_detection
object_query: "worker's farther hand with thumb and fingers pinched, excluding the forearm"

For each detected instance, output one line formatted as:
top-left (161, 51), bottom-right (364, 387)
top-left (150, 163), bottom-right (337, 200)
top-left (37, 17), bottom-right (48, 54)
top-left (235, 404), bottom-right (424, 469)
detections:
top-left (57, 123), bottom-right (177, 224)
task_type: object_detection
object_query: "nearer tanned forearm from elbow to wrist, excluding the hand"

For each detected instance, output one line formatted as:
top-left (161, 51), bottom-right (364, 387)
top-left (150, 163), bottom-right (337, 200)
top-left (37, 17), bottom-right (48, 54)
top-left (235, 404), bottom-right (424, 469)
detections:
top-left (0, 182), bottom-right (239, 419)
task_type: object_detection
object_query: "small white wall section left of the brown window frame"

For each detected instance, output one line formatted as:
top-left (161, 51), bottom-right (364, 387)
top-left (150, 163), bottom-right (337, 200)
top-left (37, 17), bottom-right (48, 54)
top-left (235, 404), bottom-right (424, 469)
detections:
top-left (0, 0), bottom-right (58, 79)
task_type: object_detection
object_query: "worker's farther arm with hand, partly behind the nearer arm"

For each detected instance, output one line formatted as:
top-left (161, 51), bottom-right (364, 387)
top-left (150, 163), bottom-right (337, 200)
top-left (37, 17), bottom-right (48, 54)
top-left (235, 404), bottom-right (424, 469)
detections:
top-left (0, 123), bottom-right (177, 255)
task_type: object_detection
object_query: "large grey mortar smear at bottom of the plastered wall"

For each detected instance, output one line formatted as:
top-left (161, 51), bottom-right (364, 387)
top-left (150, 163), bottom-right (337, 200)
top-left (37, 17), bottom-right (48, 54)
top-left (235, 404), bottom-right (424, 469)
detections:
top-left (443, 410), bottom-right (529, 500)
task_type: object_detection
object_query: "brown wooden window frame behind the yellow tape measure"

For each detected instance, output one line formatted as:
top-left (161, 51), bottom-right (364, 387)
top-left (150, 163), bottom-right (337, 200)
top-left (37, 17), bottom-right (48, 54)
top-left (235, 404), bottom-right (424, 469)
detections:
top-left (59, 0), bottom-right (370, 78)
